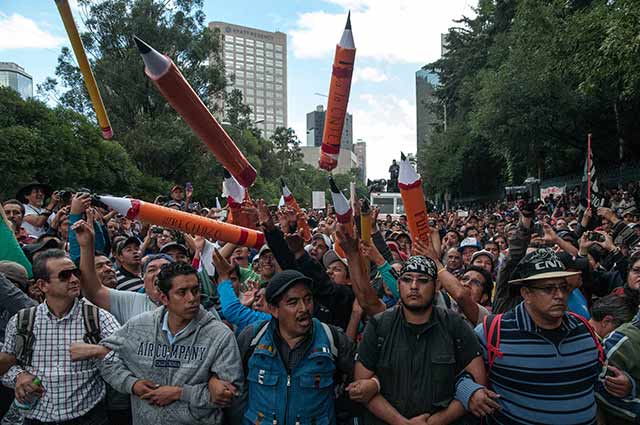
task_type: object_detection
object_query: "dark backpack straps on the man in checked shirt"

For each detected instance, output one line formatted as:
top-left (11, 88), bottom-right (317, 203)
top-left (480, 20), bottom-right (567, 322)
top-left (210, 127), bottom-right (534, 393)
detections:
top-left (15, 303), bottom-right (101, 367)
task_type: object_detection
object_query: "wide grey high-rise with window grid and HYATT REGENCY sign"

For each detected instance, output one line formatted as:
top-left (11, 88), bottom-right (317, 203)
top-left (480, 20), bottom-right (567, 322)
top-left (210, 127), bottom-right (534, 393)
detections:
top-left (209, 22), bottom-right (287, 137)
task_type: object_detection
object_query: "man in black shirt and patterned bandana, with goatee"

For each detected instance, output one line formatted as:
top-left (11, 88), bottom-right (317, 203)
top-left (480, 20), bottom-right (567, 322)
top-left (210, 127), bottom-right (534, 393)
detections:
top-left (355, 256), bottom-right (495, 424)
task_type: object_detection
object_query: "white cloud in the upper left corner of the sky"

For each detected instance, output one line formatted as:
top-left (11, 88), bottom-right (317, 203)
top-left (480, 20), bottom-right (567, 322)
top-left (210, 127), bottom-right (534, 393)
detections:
top-left (0, 12), bottom-right (65, 50)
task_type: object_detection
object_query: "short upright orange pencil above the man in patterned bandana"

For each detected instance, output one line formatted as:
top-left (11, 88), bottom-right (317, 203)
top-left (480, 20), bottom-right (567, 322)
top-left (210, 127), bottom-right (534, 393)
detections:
top-left (398, 154), bottom-right (431, 241)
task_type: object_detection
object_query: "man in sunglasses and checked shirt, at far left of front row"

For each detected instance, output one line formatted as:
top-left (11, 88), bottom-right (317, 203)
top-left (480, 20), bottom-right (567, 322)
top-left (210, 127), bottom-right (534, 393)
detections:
top-left (2, 249), bottom-right (119, 425)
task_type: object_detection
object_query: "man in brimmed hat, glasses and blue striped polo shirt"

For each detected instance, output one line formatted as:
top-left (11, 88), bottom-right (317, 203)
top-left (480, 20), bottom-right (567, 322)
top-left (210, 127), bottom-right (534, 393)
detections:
top-left (459, 248), bottom-right (601, 425)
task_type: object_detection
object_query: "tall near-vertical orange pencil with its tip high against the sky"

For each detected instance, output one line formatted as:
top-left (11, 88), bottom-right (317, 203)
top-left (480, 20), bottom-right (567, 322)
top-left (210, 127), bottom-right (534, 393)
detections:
top-left (318, 12), bottom-right (356, 171)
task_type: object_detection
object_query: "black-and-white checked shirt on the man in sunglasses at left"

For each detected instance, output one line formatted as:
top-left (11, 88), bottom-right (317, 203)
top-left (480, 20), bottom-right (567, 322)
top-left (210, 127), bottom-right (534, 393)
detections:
top-left (2, 300), bottom-right (119, 422)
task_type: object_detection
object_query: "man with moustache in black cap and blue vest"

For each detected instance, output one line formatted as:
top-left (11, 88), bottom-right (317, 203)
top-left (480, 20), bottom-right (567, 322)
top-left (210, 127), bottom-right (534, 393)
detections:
top-left (238, 270), bottom-right (355, 425)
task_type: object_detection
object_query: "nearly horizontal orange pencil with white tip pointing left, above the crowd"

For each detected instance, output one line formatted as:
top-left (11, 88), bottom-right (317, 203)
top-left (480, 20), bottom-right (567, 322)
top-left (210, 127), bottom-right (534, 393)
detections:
top-left (100, 196), bottom-right (264, 248)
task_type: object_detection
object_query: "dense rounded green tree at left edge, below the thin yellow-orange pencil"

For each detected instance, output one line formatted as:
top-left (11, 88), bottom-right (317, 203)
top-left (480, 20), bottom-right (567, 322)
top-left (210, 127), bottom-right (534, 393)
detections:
top-left (0, 88), bottom-right (154, 199)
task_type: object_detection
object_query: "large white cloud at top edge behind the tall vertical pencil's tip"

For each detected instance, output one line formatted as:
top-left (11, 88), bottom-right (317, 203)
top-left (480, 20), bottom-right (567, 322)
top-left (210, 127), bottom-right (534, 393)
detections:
top-left (289, 0), bottom-right (476, 64)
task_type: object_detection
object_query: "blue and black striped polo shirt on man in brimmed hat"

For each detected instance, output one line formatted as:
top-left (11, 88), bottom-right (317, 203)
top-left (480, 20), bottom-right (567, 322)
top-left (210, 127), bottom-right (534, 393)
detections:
top-left (476, 303), bottom-right (601, 425)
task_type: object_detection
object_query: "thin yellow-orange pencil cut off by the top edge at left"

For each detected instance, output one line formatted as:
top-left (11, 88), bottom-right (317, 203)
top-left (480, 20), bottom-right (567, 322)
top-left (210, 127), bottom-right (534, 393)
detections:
top-left (55, 0), bottom-right (113, 139)
